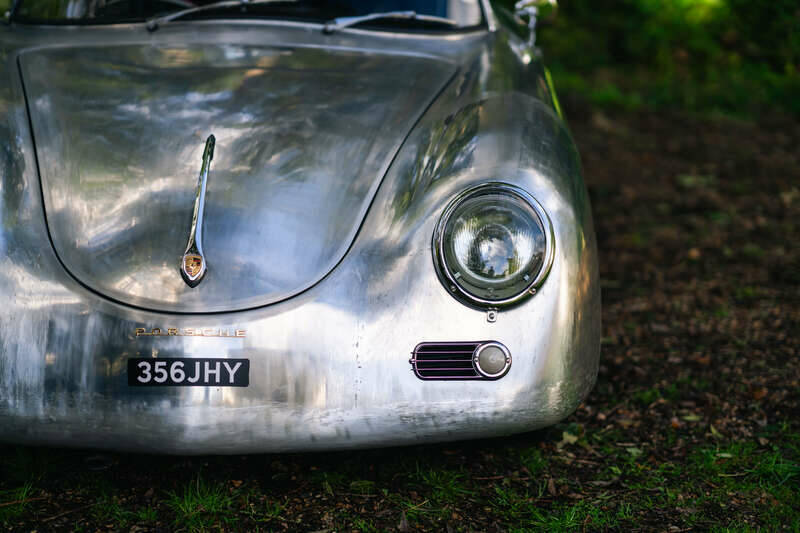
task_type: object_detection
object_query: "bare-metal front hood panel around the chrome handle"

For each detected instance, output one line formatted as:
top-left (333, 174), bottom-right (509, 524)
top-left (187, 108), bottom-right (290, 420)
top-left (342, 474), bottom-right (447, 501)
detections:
top-left (19, 44), bottom-right (455, 312)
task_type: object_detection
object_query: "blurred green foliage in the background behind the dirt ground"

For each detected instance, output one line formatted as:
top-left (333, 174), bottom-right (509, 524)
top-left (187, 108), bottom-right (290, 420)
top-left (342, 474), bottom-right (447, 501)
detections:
top-left (497, 0), bottom-right (800, 117)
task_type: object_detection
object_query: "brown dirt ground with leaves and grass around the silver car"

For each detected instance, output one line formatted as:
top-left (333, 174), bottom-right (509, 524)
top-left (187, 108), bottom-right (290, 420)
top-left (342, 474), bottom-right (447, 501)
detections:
top-left (0, 102), bottom-right (800, 532)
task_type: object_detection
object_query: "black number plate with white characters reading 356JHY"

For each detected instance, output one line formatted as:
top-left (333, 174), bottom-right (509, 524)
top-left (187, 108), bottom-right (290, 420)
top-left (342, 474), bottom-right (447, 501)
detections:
top-left (128, 357), bottom-right (250, 387)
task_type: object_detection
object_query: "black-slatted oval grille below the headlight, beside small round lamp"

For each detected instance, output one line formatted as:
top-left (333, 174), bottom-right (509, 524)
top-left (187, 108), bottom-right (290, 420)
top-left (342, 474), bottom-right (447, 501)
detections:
top-left (409, 341), bottom-right (502, 380)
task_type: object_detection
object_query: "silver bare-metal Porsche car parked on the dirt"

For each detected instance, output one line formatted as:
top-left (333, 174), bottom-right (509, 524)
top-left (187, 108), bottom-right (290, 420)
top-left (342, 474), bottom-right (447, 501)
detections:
top-left (0, 0), bottom-right (600, 453)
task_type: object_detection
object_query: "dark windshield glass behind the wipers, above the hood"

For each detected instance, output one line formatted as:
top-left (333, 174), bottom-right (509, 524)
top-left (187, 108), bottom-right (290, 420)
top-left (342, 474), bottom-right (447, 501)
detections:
top-left (13, 0), bottom-right (483, 27)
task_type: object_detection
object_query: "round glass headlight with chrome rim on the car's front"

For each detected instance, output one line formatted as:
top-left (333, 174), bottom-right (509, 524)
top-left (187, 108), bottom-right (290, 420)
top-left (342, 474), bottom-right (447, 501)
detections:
top-left (433, 183), bottom-right (553, 307)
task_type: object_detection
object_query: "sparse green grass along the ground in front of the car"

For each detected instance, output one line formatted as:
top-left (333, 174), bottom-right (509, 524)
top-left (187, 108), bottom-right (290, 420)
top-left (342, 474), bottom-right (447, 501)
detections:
top-left (0, 428), bottom-right (800, 531)
